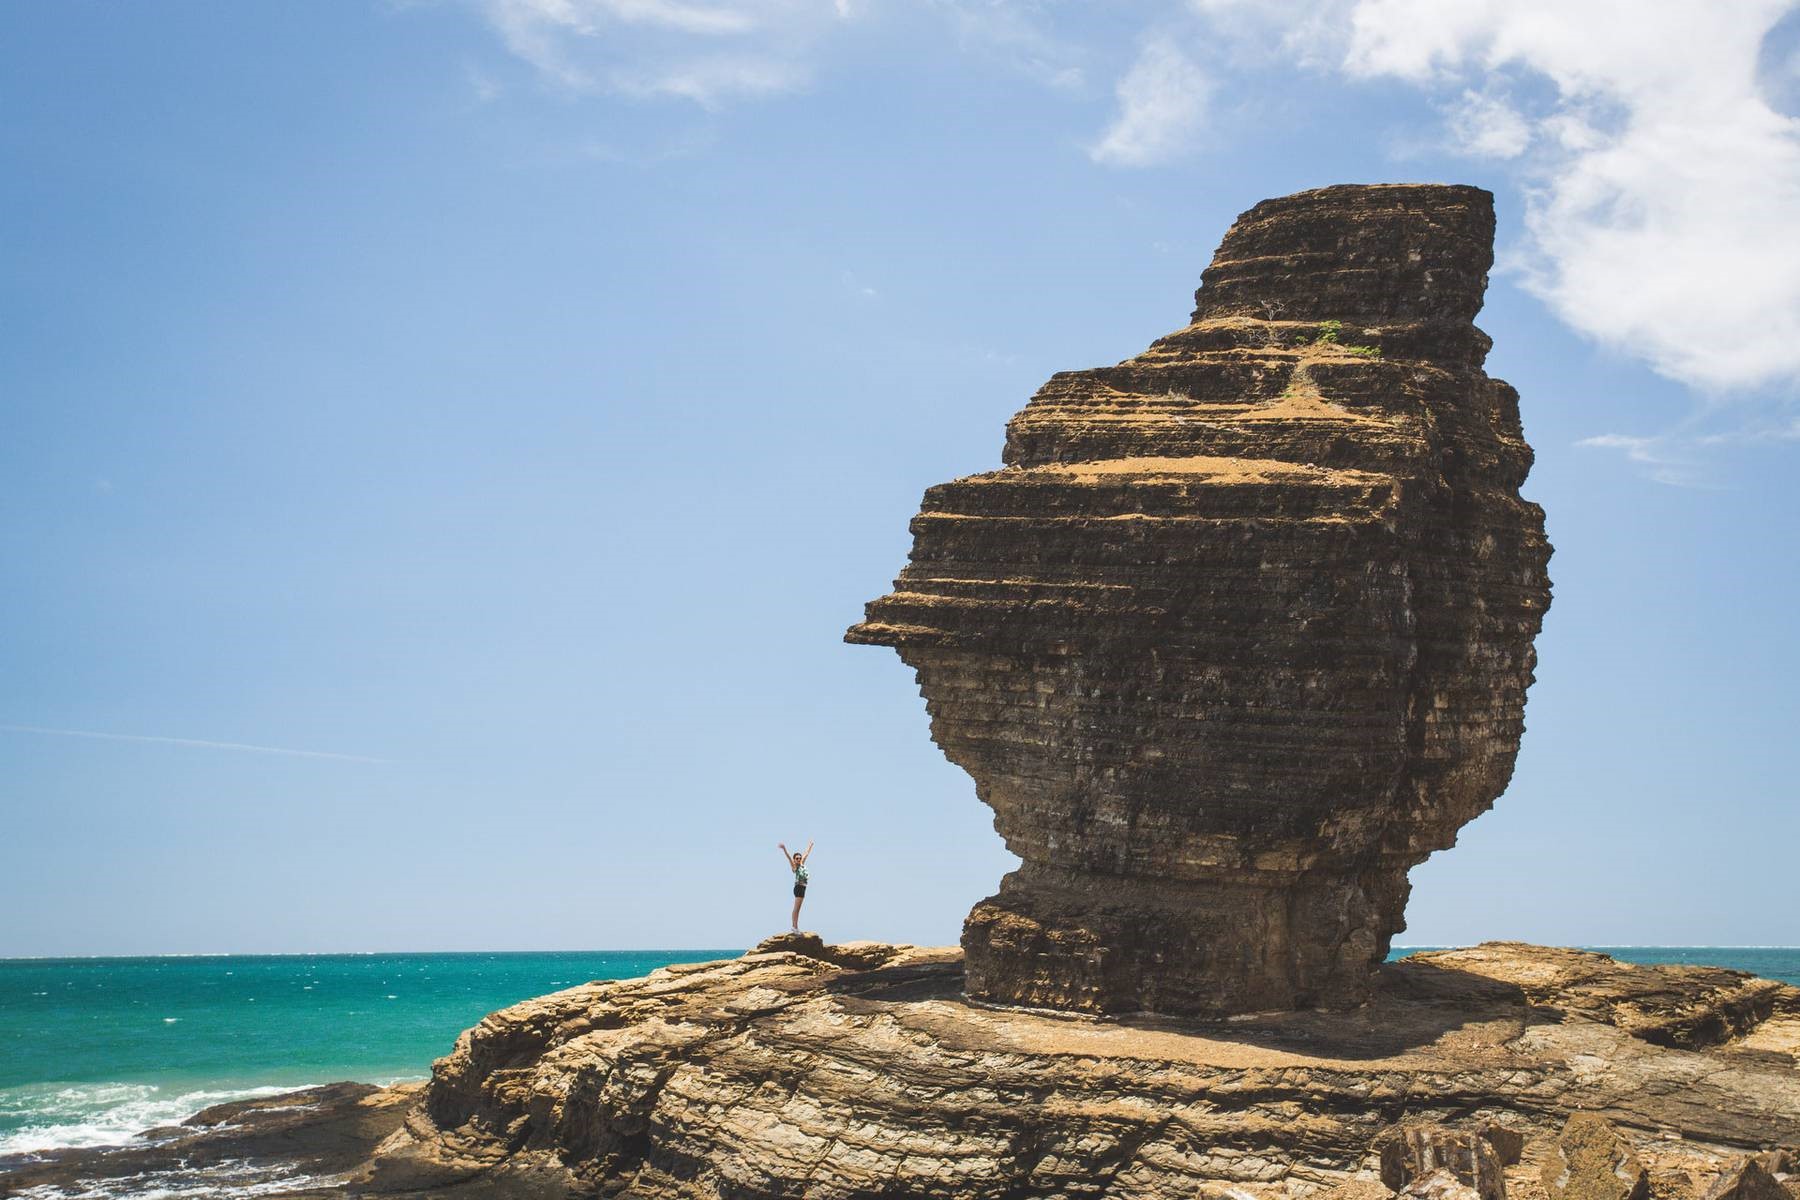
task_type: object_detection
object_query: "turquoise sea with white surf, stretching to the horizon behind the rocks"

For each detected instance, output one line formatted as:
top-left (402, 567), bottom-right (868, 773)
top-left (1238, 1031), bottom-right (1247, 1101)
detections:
top-left (0, 946), bottom-right (1800, 1160)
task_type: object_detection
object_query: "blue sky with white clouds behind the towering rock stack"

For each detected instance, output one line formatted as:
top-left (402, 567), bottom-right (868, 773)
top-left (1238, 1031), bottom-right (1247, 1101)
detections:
top-left (0, 0), bottom-right (1800, 955)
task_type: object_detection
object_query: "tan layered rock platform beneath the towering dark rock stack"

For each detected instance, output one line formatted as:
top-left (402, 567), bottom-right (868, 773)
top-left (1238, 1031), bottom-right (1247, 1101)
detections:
top-left (355, 936), bottom-right (1800, 1200)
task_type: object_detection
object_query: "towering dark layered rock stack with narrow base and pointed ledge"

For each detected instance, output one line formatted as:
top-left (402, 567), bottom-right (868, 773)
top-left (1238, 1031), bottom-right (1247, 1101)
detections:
top-left (848, 185), bottom-right (1550, 1013)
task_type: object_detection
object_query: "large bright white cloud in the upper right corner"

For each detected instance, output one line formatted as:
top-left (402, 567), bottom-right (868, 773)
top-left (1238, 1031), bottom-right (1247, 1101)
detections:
top-left (1343, 0), bottom-right (1800, 392)
